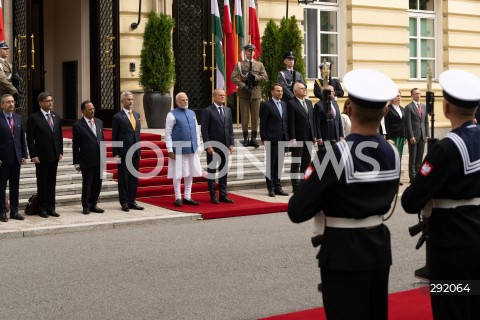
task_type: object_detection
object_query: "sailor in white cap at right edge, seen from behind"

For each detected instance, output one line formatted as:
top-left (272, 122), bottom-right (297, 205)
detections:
top-left (402, 70), bottom-right (480, 320)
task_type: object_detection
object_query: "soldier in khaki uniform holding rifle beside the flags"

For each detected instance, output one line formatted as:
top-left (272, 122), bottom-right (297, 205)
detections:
top-left (232, 43), bottom-right (268, 148)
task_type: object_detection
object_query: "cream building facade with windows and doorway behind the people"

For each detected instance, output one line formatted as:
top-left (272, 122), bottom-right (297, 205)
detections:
top-left (3, 0), bottom-right (480, 126)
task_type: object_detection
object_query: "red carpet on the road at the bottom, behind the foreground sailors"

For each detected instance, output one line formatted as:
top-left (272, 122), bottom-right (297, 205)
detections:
top-left (259, 289), bottom-right (433, 320)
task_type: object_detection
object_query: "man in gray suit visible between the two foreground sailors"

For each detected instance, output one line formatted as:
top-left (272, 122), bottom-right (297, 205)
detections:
top-left (405, 88), bottom-right (430, 183)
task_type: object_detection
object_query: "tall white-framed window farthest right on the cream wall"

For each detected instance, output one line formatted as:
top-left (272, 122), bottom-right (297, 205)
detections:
top-left (409, 0), bottom-right (437, 79)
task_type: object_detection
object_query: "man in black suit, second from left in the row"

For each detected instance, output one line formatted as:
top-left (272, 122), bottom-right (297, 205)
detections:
top-left (27, 92), bottom-right (63, 218)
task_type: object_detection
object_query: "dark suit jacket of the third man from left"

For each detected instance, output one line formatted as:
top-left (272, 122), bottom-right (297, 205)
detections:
top-left (72, 118), bottom-right (104, 169)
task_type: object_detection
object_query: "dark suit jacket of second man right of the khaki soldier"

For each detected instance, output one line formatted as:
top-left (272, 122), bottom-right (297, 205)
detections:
top-left (287, 98), bottom-right (316, 141)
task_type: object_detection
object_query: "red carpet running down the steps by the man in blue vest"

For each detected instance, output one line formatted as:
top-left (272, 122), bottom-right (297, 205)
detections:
top-left (63, 127), bottom-right (287, 219)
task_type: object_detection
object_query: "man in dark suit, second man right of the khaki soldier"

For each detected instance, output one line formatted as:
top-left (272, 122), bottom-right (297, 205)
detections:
top-left (287, 82), bottom-right (316, 192)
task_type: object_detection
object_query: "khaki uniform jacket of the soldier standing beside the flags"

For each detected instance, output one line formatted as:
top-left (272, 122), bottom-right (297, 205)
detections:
top-left (232, 60), bottom-right (268, 99)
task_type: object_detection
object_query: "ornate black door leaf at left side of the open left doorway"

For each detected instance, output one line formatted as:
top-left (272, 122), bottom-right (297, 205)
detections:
top-left (12, 0), bottom-right (46, 117)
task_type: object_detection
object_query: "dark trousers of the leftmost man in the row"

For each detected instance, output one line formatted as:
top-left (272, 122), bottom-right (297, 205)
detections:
top-left (0, 162), bottom-right (20, 215)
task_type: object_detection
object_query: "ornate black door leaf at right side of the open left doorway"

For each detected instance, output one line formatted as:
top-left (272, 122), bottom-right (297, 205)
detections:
top-left (90, 0), bottom-right (120, 127)
